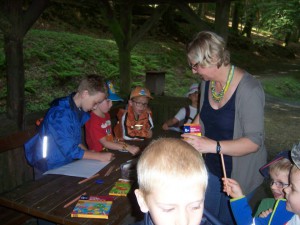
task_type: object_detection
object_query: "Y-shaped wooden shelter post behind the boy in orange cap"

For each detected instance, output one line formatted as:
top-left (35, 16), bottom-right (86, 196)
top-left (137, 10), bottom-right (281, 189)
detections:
top-left (99, 0), bottom-right (167, 96)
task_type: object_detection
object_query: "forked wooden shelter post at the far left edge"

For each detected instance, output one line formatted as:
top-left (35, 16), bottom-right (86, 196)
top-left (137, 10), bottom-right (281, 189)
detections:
top-left (0, 0), bottom-right (49, 129)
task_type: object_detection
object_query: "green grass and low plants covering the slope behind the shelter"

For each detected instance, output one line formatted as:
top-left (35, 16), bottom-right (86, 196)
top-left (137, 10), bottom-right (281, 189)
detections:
top-left (0, 30), bottom-right (300, 112)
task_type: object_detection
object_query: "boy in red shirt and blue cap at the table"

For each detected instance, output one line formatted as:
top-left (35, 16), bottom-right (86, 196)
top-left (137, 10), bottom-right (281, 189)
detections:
top-left (85, 82), bottom-right (140, 155)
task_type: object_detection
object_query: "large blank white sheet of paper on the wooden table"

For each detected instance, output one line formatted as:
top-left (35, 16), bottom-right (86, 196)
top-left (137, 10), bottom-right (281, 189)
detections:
top-left (44, 159), bottom-right (109, 178)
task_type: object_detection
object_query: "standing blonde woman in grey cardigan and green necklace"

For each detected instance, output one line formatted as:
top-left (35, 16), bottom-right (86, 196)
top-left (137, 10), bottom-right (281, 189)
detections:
top-left (182, 31), bottom-right (267, 224)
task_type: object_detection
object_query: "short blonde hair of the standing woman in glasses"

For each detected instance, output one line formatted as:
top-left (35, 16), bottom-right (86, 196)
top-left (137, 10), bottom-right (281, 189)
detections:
top-left (187, 31), bottom-right (230, 68)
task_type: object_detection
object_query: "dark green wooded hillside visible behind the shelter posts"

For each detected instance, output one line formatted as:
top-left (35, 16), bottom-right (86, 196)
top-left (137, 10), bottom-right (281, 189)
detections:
top-left (0, 0), bottom-right (300, 112)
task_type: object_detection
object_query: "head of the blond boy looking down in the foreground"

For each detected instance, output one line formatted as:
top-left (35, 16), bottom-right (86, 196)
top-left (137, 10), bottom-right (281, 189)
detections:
top-left (135, 138), bottom-right (208, 225)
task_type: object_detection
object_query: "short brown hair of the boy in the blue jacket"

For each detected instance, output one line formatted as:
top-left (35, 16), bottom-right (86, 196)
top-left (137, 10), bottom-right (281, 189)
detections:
top-left (78, 74), bottom-right (107, 95)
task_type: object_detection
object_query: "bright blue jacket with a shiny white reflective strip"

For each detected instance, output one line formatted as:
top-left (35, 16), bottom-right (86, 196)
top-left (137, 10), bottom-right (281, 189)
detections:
top-left (24, 93), bottom-right (90, 172)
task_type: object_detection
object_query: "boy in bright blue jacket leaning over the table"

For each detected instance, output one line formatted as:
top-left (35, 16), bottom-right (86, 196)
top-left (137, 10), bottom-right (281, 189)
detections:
top-left (24, 75), bottom-right (114, 179)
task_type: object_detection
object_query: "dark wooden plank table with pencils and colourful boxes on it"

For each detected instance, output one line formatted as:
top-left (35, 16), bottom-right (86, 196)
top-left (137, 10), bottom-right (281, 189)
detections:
top-left (0, 132), bottom-right (180, 225)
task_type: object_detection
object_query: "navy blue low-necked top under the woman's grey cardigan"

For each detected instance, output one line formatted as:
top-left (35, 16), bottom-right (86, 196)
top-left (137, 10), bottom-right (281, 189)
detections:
top-left (200, 82), bottom-right (236, 177)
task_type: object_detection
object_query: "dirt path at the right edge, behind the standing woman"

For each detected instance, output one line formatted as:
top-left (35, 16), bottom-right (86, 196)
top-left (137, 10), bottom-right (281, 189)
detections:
top-left (254, 59), bottom-right (300, 159)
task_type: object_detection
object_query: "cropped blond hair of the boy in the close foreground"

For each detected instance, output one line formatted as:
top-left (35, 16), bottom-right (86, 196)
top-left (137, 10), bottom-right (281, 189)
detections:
top-left (137, 138), bottom-right (208, 195)
